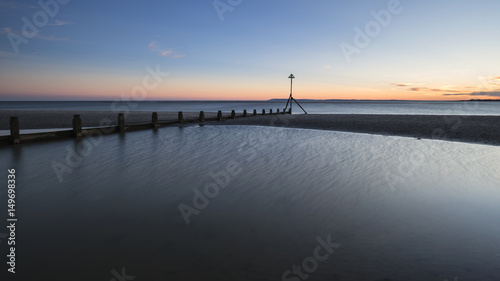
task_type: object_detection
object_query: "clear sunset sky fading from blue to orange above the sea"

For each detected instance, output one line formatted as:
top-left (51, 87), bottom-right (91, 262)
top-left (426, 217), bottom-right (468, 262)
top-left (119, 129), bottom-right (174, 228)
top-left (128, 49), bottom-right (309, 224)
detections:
top-left (0, 0), bottom-right (500, 100)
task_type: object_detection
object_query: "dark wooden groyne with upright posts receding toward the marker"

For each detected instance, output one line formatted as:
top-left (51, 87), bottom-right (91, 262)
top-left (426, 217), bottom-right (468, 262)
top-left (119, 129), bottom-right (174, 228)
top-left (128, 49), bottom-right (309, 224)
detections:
top-left (0, 109), bottom-right (291, 145)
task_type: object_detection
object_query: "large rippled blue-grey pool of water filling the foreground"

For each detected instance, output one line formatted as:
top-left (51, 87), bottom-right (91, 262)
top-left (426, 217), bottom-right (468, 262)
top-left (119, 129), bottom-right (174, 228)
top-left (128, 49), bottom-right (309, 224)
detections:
top-left (0, 126), bottom-right (500, 281)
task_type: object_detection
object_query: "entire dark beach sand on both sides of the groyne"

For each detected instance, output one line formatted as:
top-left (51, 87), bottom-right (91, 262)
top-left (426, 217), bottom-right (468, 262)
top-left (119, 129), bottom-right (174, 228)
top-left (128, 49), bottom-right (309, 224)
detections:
top-left (0, 110), bottom-right (500, 145)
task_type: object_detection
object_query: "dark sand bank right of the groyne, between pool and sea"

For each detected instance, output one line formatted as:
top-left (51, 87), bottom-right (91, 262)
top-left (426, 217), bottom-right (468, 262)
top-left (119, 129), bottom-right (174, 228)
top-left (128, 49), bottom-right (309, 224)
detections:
top-left (210, 114), bottom-right (500, 145)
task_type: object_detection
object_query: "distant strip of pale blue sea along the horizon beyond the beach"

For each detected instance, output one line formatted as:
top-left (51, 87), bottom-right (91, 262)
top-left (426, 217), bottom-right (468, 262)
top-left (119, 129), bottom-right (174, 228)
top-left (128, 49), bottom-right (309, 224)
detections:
top-left (0, 101), bottom-right (500, 115)
